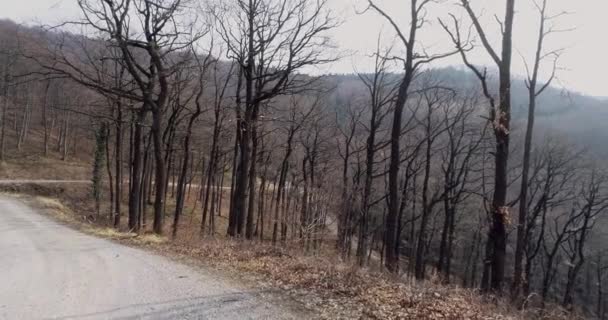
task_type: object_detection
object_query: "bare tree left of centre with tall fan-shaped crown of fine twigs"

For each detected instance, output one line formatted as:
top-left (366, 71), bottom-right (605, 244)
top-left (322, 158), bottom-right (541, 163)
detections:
top-left (216, 0), bottom-right (336, 238)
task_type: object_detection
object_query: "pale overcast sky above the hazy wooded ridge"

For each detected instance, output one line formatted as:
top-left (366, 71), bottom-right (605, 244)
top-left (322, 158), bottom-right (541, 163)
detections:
top-left (0, 0), bottom-right (608, 96)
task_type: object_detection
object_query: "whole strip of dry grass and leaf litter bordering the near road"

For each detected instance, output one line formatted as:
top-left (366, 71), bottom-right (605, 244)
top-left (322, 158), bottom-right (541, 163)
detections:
top-left (21, 192), bottom-right (572, 320)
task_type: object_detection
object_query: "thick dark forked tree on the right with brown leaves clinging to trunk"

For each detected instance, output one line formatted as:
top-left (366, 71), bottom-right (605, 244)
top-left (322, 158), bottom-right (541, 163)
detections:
top-left (441, 0), bottom-right (515, 293)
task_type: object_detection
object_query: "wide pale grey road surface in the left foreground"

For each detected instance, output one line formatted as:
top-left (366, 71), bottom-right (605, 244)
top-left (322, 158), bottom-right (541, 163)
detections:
top-left (0, 196), bottom-right (303, 320)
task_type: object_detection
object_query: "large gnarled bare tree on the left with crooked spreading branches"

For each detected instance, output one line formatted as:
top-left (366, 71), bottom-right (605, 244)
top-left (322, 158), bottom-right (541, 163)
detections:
top-left (30, 0), bottom-right (202, 234)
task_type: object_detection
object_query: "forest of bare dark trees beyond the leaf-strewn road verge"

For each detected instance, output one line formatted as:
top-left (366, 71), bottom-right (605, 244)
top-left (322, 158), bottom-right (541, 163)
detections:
top-left (0, 0), bottom-right (608, 319)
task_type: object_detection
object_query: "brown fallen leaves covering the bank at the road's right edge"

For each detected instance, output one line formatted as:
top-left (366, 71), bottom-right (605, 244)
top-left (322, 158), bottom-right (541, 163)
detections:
top-left (142, 240), bottom-right (519, 320)
